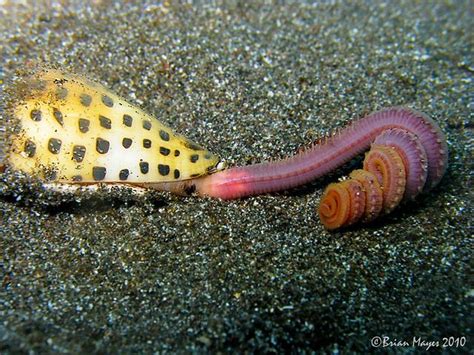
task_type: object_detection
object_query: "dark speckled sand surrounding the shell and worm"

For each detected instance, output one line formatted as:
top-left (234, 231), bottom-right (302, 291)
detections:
top-left (0, 1), bottom-right (474, 353)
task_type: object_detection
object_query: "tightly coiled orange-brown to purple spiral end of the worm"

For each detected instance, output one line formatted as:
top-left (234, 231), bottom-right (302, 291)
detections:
top-left (319, 119), bottom-right (448, 230)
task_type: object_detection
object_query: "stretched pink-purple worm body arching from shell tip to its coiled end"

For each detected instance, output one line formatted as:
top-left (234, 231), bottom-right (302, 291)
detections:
top-left (175, 107), bottom-right (448, 206)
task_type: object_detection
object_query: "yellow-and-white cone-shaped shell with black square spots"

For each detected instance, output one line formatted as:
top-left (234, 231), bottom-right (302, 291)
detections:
top-left (7, 70), bottom-right (219, 185)
